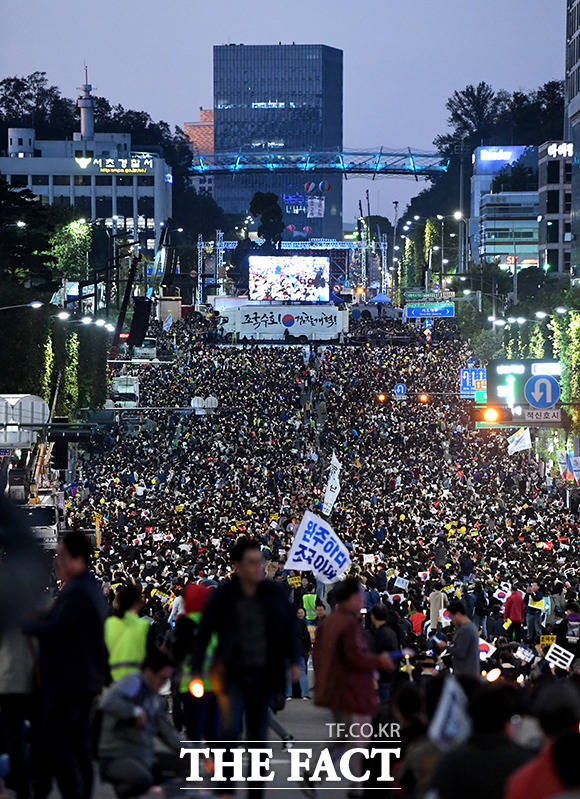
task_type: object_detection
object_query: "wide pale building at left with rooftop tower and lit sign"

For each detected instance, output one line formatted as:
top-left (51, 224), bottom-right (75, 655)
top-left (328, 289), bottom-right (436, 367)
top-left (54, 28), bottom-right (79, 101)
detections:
top-left (0, 75), bottom-right (172, 250)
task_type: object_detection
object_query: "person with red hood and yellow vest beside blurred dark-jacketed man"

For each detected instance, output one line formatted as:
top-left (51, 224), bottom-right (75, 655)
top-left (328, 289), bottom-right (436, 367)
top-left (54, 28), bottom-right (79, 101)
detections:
top-left (173, 584), bottom-right (220, 741)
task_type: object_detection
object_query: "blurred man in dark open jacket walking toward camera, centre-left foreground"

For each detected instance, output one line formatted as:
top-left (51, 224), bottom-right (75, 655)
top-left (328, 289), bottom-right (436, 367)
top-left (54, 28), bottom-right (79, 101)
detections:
top-left (192, 537), bottom-right (300, 793)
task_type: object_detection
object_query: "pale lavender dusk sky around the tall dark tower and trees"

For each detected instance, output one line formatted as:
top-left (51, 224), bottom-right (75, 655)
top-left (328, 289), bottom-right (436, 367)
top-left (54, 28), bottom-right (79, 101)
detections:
top-left (0, 0), bottom-right (565, 220)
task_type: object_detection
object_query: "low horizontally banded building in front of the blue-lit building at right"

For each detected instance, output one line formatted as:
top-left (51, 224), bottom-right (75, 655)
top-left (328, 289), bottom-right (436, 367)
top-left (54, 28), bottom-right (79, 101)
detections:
top-left (478, 191), bottom-right (539, 271)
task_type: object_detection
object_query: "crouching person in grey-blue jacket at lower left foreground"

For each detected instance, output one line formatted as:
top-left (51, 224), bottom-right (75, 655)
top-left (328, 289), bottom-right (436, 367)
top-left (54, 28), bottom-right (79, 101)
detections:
top-left (99, 649), bottom-right (185, 799)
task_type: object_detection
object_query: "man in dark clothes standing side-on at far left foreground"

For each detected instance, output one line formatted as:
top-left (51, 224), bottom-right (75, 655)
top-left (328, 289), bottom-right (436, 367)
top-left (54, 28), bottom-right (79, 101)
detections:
top-left (30, 533), bottom-right (107, 799)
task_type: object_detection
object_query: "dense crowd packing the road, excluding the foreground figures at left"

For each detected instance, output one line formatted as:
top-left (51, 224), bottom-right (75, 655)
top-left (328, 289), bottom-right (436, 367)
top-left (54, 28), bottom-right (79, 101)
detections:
top-left (1, 317), bottom-right (580, 799)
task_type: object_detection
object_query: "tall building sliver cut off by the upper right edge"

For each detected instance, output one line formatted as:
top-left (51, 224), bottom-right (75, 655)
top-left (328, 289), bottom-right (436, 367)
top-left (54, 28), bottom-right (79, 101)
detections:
top-left (564, 0), bottom-right (580, 280)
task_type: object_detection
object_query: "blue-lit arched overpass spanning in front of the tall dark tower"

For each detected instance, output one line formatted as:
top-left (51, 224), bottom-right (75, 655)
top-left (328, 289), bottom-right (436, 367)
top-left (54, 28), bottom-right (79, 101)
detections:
top-left (191, 147), bottom-right (449, 180)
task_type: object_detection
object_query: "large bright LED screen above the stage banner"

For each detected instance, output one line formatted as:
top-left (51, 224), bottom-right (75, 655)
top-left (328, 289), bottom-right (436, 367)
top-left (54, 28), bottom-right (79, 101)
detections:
top-left (250, 255), bottom-right (330, 302)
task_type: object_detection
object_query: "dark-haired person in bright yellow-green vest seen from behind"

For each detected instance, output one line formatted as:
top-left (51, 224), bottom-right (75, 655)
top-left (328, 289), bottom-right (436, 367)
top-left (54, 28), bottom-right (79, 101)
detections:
top-left (105, 583), bottom-right (151, 682)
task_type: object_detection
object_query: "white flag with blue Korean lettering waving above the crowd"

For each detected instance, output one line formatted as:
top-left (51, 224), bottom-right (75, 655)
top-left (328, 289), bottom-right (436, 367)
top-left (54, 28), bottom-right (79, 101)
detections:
top-left (286, 510), bottom-right (350, 583)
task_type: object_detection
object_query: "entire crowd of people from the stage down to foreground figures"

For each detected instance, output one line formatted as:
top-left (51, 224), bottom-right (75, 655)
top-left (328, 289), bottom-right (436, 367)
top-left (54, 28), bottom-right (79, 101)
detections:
top-left (0, 317), bottom-right (580, 799)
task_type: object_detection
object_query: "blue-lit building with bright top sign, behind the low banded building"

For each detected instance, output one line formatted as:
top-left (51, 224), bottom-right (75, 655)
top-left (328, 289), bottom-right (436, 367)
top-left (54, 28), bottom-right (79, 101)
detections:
top-left (468, 145), bottom-right (535, 264)
